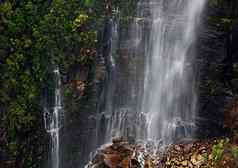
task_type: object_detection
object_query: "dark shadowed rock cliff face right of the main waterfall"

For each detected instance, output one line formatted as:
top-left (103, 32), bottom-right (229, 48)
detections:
top-left (197, 0), bottom-right (238, 137)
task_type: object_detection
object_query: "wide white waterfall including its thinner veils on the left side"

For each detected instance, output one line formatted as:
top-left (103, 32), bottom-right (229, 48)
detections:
top-left (88, 0), bottom-right (205, 164)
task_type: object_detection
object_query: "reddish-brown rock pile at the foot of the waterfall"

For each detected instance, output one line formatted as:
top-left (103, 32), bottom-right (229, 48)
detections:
top-left (88, 137), bottom-right (238, 168)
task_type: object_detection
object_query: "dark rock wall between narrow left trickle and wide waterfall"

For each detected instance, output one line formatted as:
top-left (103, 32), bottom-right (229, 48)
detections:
top-left (61, 25), bottom-right (108, 168)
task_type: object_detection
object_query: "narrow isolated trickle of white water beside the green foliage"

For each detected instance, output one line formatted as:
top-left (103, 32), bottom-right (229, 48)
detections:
top-left (44, 68), bottom-right (64, 168)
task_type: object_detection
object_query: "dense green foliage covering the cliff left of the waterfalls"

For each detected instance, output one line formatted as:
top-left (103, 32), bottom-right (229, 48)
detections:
top-left (0, 0), bottom-right (105, 168)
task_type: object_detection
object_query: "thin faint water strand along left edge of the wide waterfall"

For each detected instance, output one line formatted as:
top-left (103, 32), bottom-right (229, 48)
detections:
top-left (96, 19), bottom-right (118, 145)
